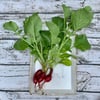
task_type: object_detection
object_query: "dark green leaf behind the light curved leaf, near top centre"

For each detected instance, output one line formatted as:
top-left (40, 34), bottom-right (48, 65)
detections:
top-left (52, 16), bottom-right (64, 31)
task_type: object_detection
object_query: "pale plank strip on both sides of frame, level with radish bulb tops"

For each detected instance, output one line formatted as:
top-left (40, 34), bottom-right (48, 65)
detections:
top-left (0, 65), bottom-right (100, 77)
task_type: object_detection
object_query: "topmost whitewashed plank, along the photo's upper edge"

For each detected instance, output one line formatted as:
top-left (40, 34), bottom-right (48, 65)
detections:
top-left (0, 0), bottom-right (100, 13)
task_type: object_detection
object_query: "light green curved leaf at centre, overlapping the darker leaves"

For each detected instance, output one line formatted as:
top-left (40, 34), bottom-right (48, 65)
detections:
top-left (46, 21), bottom-right (60, 44)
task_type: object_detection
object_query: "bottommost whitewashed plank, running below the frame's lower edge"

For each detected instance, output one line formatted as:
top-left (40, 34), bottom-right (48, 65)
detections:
top-left (0, 92), bottom-right (100, 100)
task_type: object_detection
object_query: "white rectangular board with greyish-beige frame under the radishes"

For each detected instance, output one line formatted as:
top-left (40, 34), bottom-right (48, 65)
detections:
top-left (30, 50), bottom-right (76, 96)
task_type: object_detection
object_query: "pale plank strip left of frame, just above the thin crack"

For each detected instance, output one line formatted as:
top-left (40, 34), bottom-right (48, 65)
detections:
top-left (0, 65), bottom-right (29, 77)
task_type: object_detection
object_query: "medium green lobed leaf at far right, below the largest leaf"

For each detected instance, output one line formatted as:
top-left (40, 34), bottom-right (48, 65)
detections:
top-left (74, 34), bottom-right (91, 51)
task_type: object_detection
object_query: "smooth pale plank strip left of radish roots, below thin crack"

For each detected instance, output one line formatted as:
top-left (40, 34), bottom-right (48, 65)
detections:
top-left (0, 76), bottom-right (29, 91)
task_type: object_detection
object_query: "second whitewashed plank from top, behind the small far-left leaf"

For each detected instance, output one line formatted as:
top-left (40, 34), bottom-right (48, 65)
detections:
top-left (0, 13), bottom-right (100, 39)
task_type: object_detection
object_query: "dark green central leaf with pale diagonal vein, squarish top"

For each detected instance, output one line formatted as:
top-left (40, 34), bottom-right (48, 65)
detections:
top-left (40, 30), bottom-right (51, 47)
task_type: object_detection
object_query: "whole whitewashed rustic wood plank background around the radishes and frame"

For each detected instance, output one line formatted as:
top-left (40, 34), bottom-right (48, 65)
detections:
top-left (0, 0), bottom-right (100, 100)
